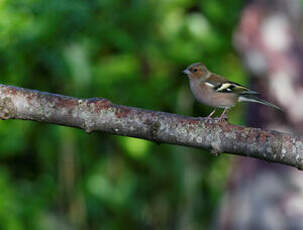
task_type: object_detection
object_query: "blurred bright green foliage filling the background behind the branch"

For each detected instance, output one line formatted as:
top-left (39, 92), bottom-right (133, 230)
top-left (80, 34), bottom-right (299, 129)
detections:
top-left (0, 0), bottom-right (245, 230)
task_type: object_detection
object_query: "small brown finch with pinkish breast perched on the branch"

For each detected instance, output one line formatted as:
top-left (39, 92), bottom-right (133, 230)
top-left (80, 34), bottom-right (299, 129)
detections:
top-left (183, 62), bottom-right (281, 121)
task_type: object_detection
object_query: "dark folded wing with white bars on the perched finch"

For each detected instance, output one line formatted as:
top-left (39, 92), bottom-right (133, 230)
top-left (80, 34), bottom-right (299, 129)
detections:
top-left (205, 74), bottom-right (259, 95)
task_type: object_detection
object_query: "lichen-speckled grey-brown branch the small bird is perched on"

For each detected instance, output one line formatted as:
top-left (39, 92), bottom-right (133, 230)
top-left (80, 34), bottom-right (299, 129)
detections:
top-left (0, 84), bottom-right (303, 169)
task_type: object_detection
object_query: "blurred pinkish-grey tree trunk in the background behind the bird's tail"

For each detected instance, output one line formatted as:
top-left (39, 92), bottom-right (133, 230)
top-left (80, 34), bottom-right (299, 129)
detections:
top-left (214, 0), bottom-right (303, 230)
